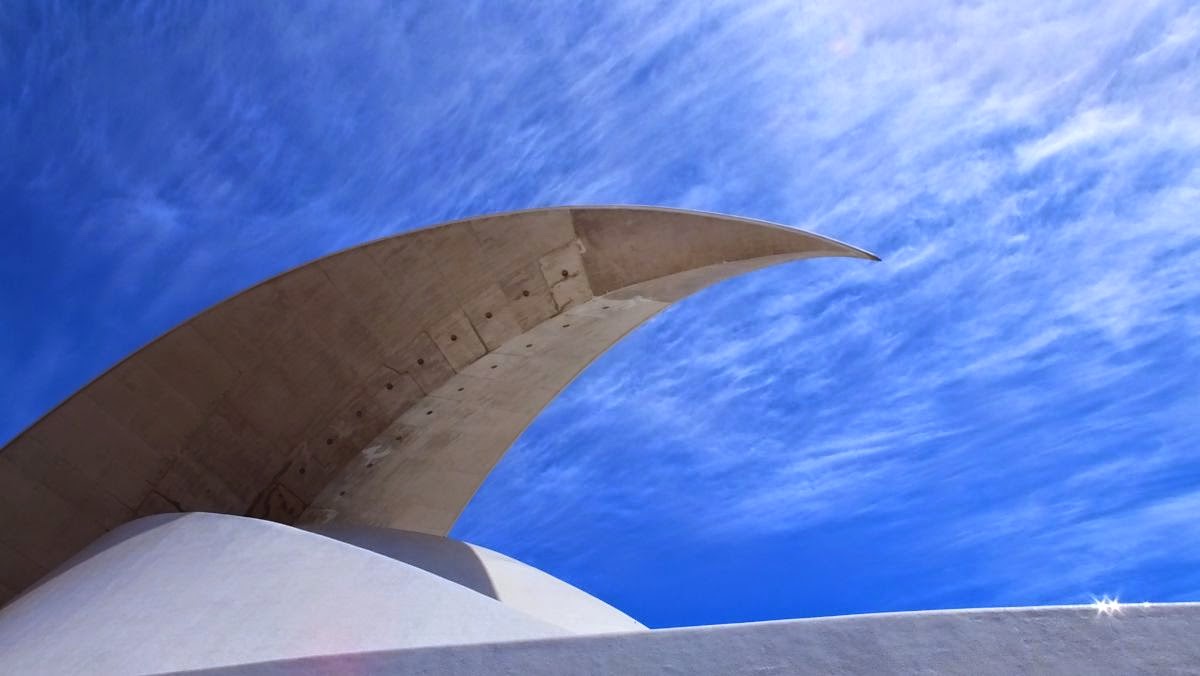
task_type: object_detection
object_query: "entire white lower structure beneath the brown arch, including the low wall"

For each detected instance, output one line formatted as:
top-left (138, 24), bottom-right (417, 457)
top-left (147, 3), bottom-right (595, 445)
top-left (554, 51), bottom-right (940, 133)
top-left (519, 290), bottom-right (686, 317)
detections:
top-left (9, 514), bottom-right (1200, 676)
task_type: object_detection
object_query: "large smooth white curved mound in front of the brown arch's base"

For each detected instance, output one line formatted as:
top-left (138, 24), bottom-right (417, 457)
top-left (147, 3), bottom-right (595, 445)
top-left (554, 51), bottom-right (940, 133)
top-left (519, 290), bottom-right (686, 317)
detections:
top-left (0, 513), bottom-right (582, 674)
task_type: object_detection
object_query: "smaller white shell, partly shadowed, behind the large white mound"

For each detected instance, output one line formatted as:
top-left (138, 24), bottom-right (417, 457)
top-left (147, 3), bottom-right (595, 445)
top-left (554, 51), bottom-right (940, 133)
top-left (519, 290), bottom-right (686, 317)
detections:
top-left (316, 526), bottom-right (646, 634)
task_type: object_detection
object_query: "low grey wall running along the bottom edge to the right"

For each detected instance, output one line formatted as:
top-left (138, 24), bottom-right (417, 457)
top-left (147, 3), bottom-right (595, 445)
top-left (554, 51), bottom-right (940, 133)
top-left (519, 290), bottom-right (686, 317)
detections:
top-left (180, 604), bottom-right (1200, 676)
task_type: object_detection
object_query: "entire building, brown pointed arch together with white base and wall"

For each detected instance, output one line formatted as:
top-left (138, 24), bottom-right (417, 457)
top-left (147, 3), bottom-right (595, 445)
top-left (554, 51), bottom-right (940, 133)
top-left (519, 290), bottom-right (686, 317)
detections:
top-left (0, 207), bottom-right (1200, 674)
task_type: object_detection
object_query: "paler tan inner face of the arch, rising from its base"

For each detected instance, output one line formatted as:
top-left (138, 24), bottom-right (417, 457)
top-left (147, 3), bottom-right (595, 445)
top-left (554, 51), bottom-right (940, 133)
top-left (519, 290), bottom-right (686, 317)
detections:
top-left (298, 297), bottom-right (666, 534)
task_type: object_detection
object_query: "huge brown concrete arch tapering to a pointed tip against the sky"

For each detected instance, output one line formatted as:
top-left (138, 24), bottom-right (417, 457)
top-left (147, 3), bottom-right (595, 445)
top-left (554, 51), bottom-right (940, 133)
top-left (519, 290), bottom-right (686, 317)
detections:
top-left (0, 208), bottom-right (874, 597)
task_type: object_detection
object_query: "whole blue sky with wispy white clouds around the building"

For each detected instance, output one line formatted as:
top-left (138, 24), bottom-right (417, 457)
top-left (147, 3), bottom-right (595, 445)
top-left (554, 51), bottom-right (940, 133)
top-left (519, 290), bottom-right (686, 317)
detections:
top-left (0, 0), bottom-right (1200, 626)
